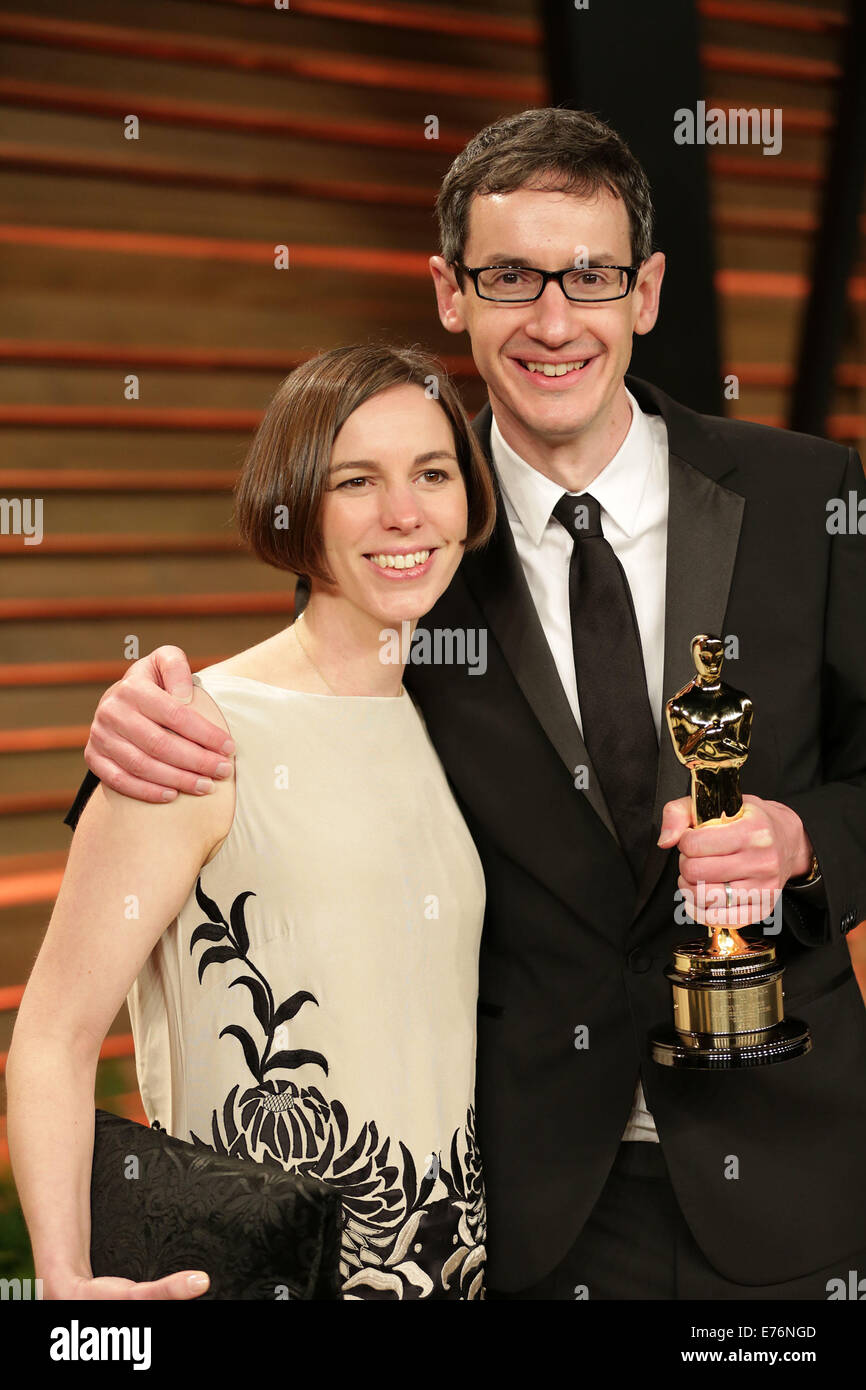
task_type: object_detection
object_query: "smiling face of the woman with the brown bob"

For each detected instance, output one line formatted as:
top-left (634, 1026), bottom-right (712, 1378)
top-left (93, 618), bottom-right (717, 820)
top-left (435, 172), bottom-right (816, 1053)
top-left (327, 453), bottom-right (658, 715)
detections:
top-left (321, 384), bottom-right (468, 627)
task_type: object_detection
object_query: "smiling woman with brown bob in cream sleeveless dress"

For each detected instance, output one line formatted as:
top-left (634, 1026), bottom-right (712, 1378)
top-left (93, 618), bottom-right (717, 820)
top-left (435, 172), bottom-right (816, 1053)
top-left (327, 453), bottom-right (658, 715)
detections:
top-left (7, 346), bottom-right (495, 1298)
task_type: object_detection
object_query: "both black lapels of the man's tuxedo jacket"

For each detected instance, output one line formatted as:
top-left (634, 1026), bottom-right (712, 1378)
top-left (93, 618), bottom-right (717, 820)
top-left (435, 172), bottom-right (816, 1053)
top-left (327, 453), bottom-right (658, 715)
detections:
top-left (460, 377), bottom-right (745, 916)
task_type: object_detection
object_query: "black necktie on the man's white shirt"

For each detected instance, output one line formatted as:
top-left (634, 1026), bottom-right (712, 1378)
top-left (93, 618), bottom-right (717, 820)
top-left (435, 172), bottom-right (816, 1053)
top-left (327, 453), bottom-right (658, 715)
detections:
top-left (553, 492), bottom-right (659, 884)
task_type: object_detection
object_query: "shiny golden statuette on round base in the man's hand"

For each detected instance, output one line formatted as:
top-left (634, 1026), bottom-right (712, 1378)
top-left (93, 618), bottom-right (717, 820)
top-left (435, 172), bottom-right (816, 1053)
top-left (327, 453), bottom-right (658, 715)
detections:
top-left (649, 632), bottom-right (812, 1070)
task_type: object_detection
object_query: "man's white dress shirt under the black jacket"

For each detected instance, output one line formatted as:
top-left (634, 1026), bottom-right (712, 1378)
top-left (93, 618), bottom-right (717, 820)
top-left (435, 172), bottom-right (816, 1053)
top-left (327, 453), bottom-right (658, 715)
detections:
top-left (491, 391), bottom-right (667, 1143)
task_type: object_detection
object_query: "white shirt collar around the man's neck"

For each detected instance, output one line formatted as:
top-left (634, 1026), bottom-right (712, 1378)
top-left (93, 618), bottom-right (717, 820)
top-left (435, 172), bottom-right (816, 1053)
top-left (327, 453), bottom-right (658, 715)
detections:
top-left (491, 388), bottom-right (653, 545)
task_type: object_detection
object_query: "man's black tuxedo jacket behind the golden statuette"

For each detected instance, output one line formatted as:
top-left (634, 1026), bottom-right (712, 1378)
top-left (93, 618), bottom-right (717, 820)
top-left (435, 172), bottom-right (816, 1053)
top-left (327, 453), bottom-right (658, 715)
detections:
top-left (67, 378), bottom-right (866, 1291)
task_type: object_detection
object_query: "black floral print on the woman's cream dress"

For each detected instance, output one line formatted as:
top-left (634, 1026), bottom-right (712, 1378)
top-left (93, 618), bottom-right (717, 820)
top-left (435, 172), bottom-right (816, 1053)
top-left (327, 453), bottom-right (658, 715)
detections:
top-left (189, 877), bottom-right (487, 1300)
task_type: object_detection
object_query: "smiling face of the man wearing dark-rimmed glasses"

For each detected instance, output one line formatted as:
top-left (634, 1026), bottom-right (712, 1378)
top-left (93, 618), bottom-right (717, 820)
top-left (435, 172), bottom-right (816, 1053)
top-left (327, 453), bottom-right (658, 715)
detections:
top-left (430, 188), bottom-right (664, 471)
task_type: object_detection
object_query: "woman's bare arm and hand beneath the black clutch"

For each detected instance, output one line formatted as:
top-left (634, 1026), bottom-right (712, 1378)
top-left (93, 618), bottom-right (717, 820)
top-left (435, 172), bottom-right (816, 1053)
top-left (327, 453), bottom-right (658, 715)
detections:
top-left (7, 688), bottom-right (235, 1298)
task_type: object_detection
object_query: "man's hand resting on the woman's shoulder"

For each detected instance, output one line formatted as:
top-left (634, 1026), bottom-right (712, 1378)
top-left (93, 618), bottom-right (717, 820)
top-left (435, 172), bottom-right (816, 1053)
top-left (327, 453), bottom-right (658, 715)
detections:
top-left (85, 646), bottom-right (235, 802)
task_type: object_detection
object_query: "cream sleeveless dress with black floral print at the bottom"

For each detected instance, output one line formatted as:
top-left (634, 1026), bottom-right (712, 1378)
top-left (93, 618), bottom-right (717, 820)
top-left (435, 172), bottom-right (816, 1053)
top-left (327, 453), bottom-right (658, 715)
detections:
top-left (128, 664), bottom-right (485, 1298)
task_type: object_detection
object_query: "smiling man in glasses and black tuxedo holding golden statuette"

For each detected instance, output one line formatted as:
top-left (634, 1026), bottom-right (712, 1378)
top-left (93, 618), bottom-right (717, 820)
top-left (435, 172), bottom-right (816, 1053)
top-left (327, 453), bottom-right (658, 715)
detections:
top-left (62, 108), bottom-right (866, 1298)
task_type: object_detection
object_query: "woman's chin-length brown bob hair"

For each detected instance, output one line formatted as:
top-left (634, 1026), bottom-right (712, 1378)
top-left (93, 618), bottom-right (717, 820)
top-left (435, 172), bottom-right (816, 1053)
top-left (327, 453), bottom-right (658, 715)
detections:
top-left (235, 343), bottom-right (496, 584)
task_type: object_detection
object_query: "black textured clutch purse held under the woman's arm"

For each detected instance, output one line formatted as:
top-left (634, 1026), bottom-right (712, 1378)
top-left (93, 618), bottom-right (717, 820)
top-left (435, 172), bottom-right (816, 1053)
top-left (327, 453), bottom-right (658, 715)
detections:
top-left (90, 1109), bottom-right (342, 1302)
